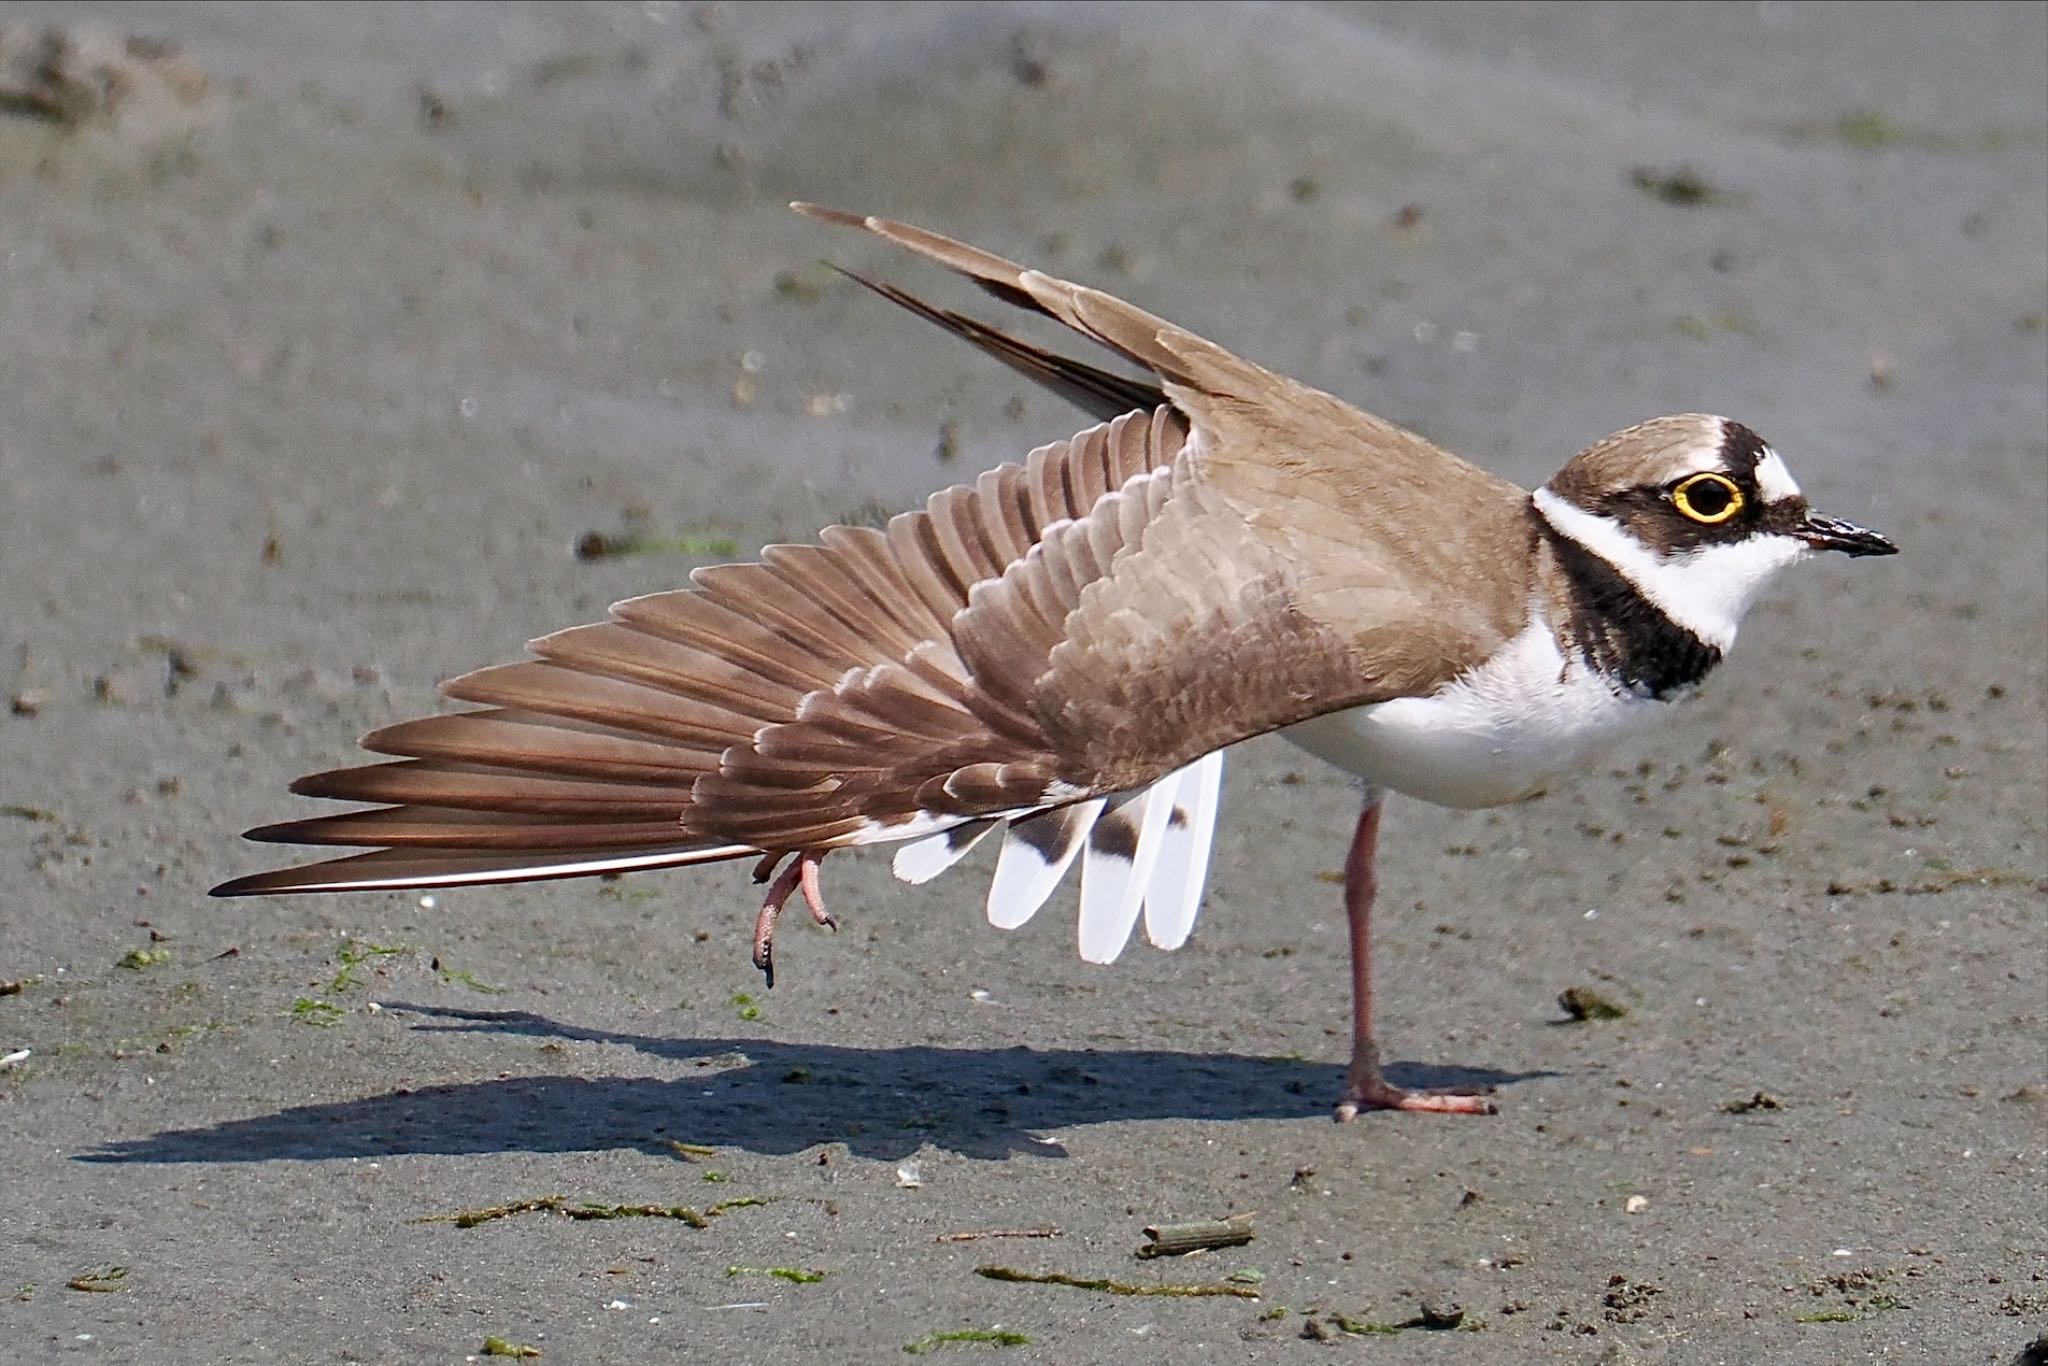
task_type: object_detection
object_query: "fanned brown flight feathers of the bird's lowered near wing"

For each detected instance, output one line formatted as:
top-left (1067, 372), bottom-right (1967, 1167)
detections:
top-left (215, 408), bottom-right (1186, 895)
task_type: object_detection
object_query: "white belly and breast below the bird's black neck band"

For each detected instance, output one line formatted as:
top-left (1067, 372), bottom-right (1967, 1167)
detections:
top-left (1280, 621), bottom-right (1669, 807)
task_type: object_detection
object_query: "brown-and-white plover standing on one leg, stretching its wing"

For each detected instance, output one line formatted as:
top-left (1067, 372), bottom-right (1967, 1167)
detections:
top-left (213, 203), bottom-right (1896, 1122)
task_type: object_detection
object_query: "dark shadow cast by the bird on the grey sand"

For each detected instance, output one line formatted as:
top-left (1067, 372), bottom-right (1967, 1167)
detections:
top-left (78, 1004), bottom-right (1552, 1163)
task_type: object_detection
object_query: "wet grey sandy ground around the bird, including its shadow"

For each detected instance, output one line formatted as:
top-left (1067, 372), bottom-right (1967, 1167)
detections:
top-left (0, 4), bottom-right (2048, 1366)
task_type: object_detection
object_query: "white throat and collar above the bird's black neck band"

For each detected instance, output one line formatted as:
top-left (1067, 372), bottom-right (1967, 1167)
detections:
top-left (1532, 487), bottom-right (1812, 653)
